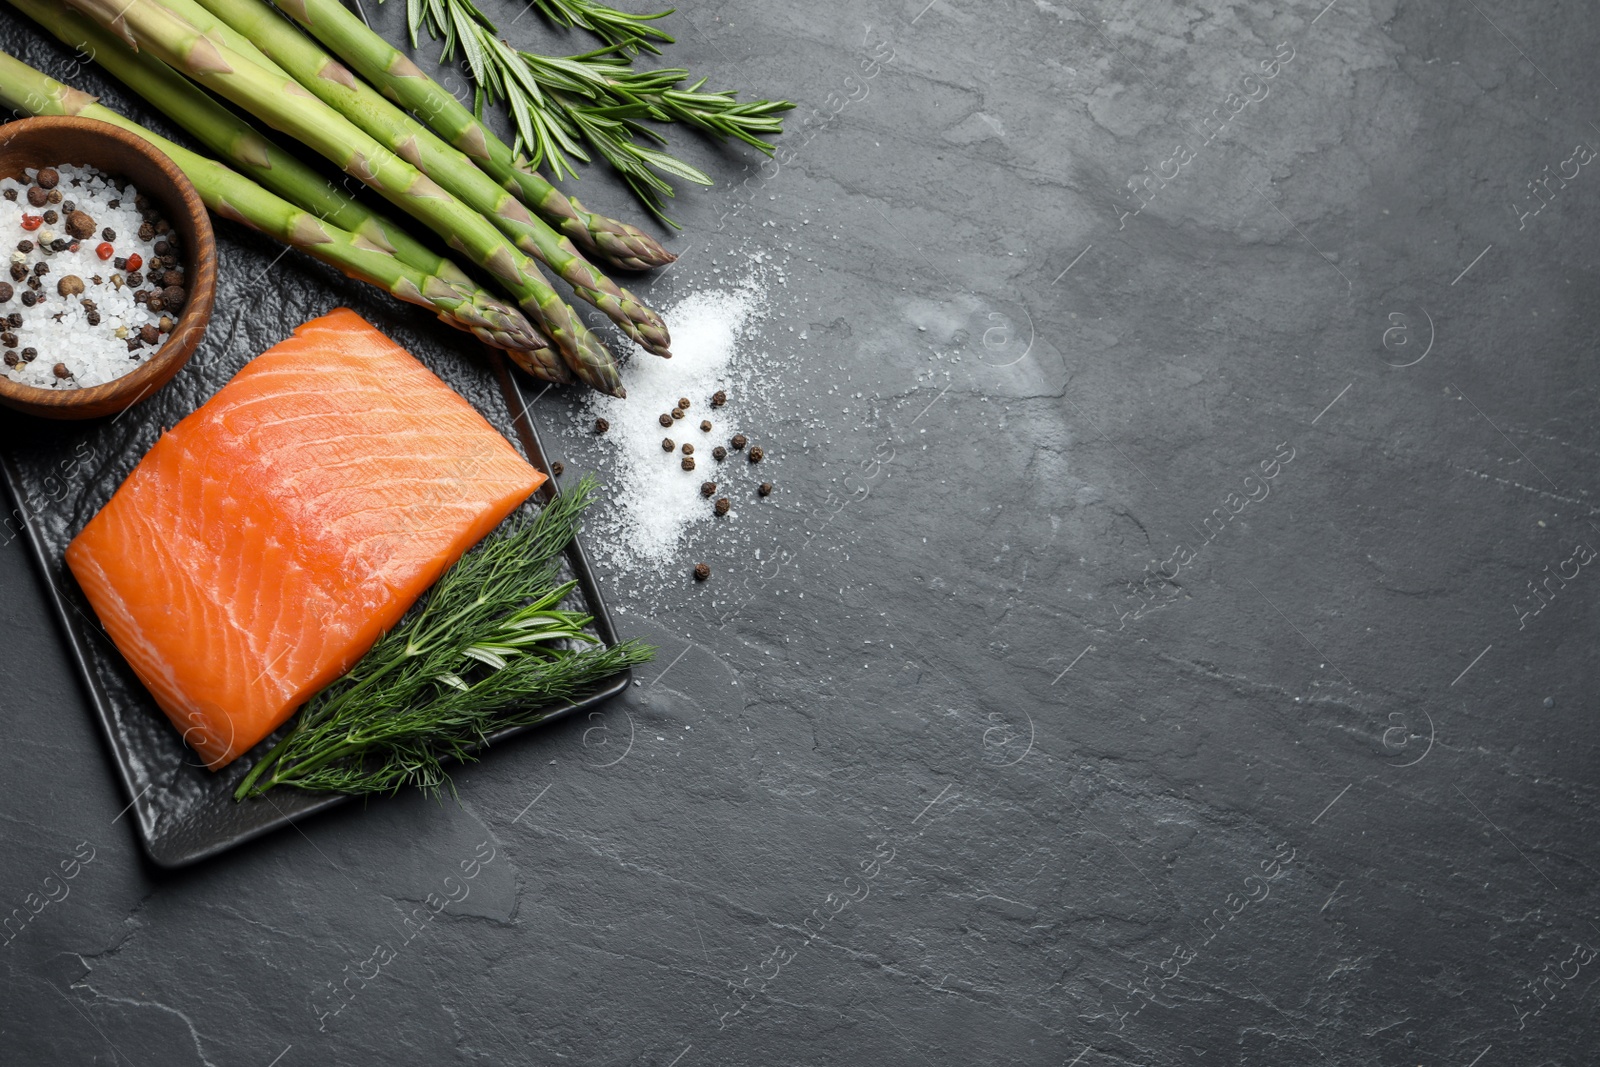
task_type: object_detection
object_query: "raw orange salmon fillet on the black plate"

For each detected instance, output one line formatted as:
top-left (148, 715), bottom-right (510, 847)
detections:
top-left (67, 309), bottom-right (544, 771)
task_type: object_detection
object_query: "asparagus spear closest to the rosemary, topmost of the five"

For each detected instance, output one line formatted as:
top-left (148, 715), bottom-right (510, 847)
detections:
top-left (275, 0), bottom-right (677, 270)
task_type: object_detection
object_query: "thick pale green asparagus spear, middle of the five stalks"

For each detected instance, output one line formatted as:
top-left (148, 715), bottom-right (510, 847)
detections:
top-left (66, 0), bottom-right (622, 395)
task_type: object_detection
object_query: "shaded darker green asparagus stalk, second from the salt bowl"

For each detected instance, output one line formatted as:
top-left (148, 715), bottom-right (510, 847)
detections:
top-left (10, 0), bottom-right (474, 286)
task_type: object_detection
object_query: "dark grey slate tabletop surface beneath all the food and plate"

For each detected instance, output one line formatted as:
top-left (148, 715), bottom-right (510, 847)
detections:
top-left (0, 0), bottom-right (1600, 1067)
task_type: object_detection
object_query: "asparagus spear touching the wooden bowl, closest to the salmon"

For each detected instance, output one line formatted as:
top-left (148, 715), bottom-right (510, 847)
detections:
top-left (0, 51), bottom-right (549, 358)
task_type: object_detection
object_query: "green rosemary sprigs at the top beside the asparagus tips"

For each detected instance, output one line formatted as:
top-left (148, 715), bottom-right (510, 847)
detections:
top-left (387, 0), bottom-right (794, 226)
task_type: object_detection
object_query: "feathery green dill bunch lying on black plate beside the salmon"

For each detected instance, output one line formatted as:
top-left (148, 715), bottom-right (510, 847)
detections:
top-left (234, 478), bottom-right (654, 800)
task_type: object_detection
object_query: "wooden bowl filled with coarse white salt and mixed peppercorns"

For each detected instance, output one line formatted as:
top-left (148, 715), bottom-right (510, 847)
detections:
top-left (0, 117), bottom-right (216, 419)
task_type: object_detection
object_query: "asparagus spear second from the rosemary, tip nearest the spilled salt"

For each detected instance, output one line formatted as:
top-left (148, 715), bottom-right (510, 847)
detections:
top-left (183, 0), bottom-right (672, 355)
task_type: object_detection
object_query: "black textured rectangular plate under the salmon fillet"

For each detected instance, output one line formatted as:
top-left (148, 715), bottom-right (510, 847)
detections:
top-left (0, 292), bottom-right (629, 867)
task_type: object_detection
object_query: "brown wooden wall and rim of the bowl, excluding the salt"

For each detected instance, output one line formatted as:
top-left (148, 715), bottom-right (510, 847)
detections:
top-left (0, 117), bottom-right (216, 419)
